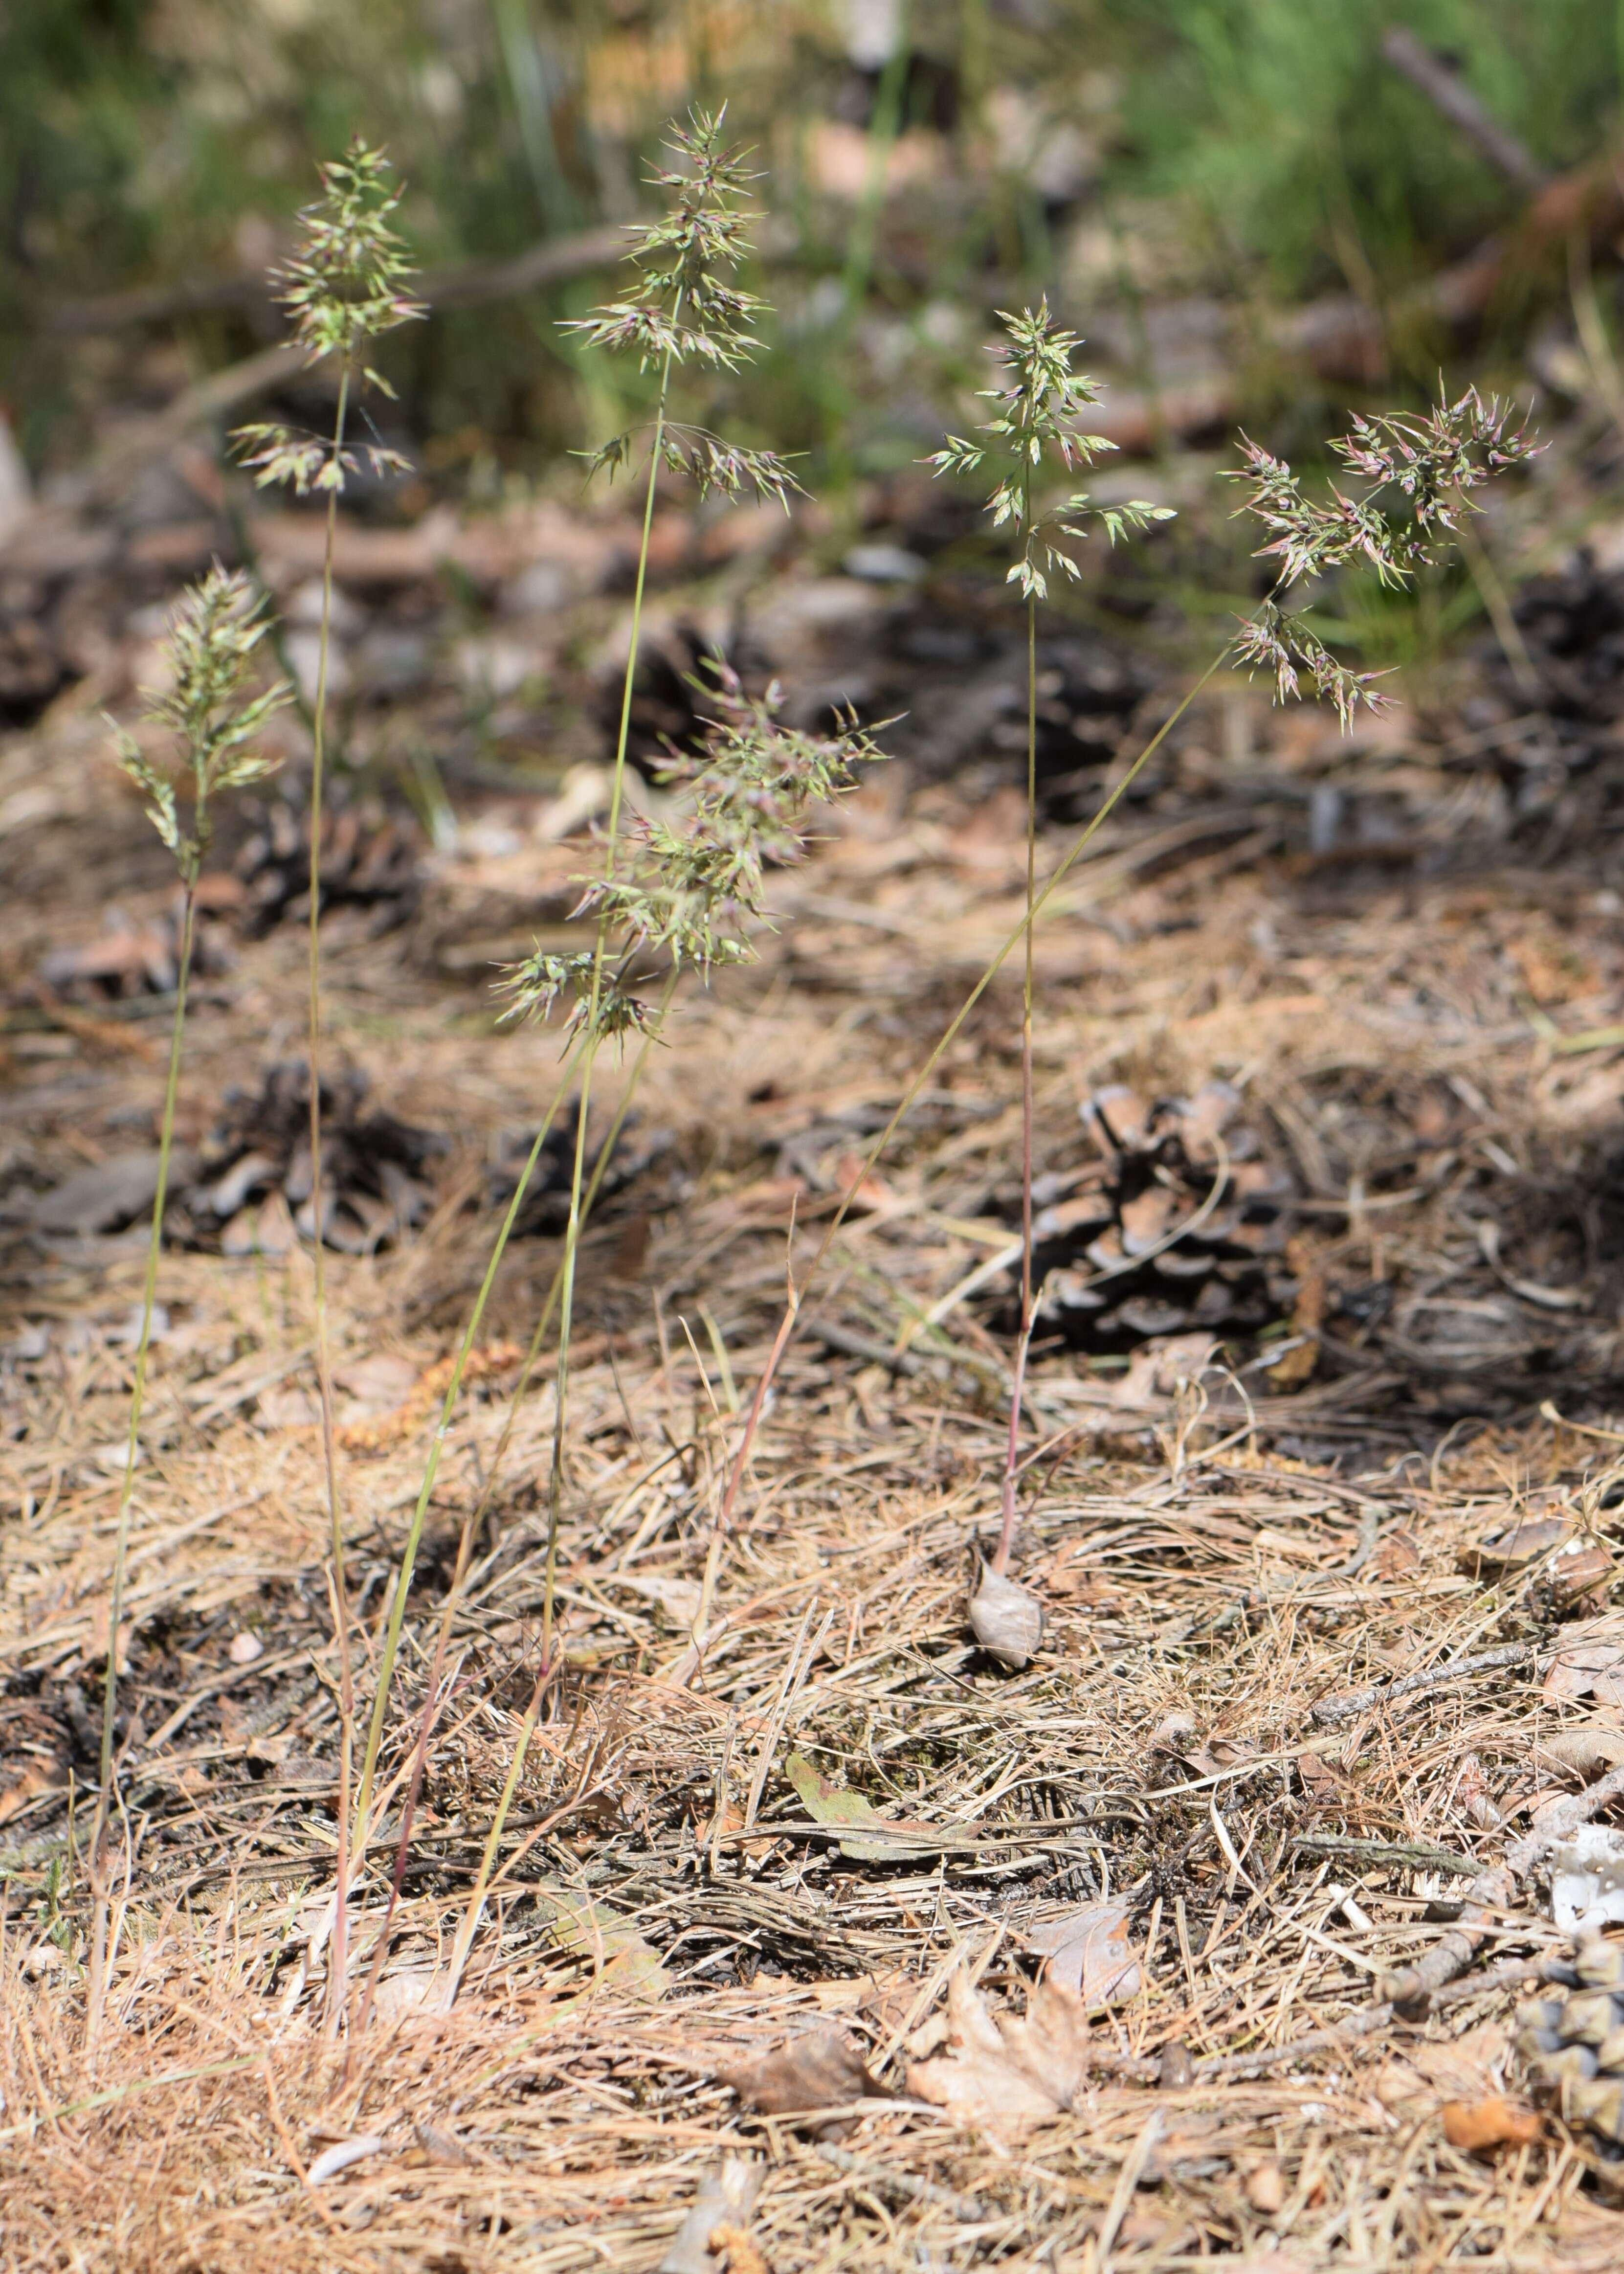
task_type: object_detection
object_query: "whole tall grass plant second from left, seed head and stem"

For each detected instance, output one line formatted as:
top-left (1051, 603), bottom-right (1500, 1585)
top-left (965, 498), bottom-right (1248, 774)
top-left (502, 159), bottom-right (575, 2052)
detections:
top-left (237, 139), bottom-right (421, 2028)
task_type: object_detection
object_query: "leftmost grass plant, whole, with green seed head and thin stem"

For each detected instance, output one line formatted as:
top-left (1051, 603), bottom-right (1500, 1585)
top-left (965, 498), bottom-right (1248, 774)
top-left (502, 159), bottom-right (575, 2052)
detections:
top-left (91, 566), bottom-right (291, 2035)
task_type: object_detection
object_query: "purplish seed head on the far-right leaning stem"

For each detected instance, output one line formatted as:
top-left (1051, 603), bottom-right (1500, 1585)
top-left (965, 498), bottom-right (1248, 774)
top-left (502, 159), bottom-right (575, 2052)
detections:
top-left (1228, 386), bottom-right (1540, 728)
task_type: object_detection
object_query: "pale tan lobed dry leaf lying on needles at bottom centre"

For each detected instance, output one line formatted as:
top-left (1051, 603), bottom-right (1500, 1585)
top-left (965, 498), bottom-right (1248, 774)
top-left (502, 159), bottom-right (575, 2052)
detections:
top-left (908, 1967), bottom-right (1090, 2133)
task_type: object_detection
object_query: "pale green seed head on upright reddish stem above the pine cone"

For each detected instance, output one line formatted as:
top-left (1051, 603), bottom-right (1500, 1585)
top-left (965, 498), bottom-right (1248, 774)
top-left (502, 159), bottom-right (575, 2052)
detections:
top-left (926, 298), bottom-right (1174, 600)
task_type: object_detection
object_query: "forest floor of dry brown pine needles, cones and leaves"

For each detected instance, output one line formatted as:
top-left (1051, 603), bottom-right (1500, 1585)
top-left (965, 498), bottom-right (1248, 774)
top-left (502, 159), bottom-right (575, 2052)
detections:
top-left (0, 452), bottom-right (1624, 2274)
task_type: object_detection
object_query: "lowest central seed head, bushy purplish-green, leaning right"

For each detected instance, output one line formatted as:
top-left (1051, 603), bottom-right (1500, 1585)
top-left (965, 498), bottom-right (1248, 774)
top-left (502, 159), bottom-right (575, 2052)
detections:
top-left (498, 662), bottom-right (885, 1039)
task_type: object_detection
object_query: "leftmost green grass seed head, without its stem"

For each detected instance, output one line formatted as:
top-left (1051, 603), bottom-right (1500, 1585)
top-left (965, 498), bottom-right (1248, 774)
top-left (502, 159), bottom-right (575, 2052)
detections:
top-left (109, 564), bottom-right (291, 880)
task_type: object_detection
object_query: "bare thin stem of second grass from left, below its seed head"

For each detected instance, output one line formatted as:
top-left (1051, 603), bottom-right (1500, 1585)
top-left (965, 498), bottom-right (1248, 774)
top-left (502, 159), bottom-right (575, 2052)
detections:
top-left (307, 360), bottom-right (355, 2035)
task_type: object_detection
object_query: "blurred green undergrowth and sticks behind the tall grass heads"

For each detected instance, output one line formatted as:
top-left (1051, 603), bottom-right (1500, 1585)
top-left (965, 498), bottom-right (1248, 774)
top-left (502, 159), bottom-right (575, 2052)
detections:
top-left (0, 0), bottom-right (1624, 500)
